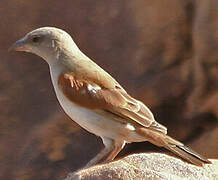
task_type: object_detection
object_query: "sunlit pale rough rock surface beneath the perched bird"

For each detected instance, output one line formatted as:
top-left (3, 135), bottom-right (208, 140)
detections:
top-left (65, 153), bottom-right (218, 180)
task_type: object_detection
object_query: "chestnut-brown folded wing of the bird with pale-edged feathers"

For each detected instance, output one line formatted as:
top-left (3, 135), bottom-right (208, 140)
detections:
top-left (58, 73), bottom-right (166, 133)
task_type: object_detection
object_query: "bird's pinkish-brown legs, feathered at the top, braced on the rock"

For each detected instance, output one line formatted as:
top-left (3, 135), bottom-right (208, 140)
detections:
top-left (85, 137), bottom-right (125, 168)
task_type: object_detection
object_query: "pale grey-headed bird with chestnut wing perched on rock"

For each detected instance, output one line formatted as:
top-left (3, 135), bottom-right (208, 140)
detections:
top-left (9, 27), bottom-right (211, 168)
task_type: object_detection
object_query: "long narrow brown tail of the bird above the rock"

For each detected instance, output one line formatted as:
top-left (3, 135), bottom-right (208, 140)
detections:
top-left (138, 128), bottom-right (211, 166)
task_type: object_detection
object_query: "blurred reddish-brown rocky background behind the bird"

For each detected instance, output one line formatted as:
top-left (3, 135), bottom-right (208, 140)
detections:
top-left (0, 0), bottom-right (218, 180)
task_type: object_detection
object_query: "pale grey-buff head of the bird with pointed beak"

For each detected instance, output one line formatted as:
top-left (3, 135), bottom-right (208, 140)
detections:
top-left (9, 27), bottom-right (78, 63)
